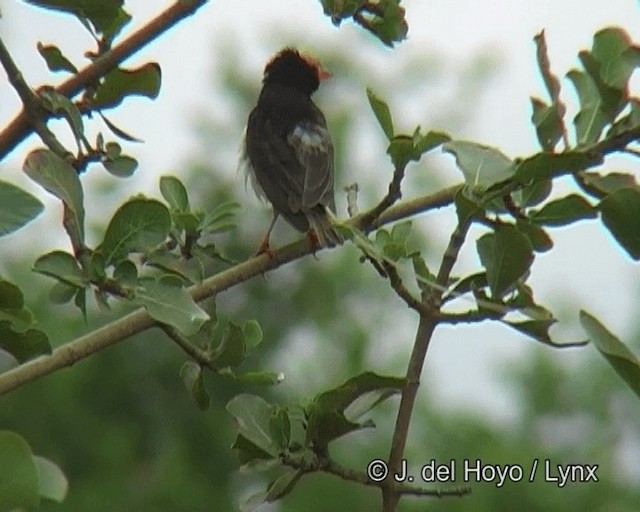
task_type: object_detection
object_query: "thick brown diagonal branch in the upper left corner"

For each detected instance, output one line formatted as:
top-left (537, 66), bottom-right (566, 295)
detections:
top-left (0, 0), bottom-right (207, 160)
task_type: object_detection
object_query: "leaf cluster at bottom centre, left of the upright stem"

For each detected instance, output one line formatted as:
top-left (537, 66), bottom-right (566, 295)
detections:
top-left (227, 372), bottom-right (404, 511)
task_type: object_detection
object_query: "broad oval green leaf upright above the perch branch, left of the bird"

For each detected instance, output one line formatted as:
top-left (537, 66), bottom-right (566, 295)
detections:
top-left (101, 197), bottom-right (171, 265)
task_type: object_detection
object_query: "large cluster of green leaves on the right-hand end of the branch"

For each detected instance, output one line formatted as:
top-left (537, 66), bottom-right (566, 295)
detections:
top-left (355, 28), bottom-right (640, 392)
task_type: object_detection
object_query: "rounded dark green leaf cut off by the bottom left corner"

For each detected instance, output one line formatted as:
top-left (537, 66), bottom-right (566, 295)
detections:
top-left (0, 430), bottom-right (40, 511)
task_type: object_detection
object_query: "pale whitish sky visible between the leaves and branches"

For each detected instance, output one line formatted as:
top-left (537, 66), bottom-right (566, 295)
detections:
top-left (0, 0), bottom-right (640, 436)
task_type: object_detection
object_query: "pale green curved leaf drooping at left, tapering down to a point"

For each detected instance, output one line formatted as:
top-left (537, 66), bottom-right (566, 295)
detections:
top-left (23, 149), bottom-right (84, 242)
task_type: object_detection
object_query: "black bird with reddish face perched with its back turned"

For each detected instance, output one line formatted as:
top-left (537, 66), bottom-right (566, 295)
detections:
top-left (240, 47), bottom-right (344, 254)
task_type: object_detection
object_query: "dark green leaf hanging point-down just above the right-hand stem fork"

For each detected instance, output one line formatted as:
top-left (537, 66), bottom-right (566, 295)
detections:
top-left (477, 224), bottom-right (533, 298)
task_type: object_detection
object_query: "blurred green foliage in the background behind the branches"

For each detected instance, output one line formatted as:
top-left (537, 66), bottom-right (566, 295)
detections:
top-left (0, 25), bottom-right (640, 512)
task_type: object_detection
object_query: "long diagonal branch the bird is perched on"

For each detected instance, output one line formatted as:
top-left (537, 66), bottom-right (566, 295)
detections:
top-left (0, 187), bottom-right (455, 396)
